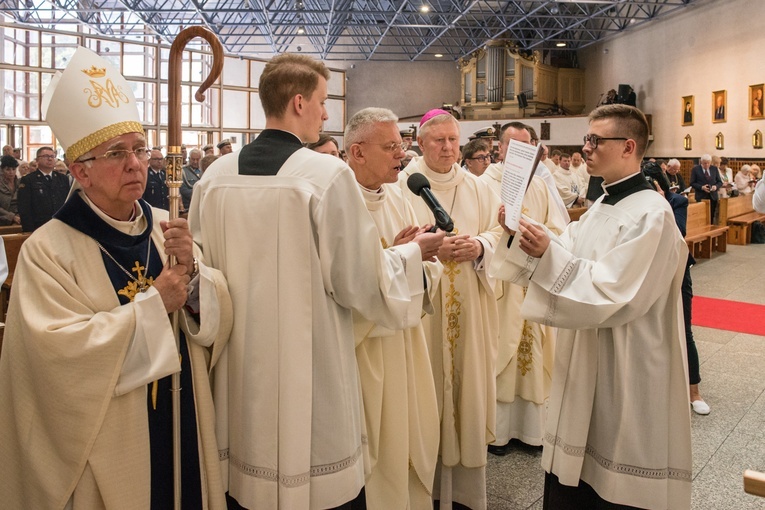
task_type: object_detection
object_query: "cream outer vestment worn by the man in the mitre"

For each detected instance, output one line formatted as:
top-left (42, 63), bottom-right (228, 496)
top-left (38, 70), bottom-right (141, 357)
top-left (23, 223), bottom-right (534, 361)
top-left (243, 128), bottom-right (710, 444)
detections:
top-left (0, 199), bottom-right (232, 510)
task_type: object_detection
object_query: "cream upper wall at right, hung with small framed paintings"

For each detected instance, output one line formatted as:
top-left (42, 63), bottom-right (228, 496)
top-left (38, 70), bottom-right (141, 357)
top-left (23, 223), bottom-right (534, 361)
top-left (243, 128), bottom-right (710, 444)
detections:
top-left (579, 0), bottom-right (765, 158)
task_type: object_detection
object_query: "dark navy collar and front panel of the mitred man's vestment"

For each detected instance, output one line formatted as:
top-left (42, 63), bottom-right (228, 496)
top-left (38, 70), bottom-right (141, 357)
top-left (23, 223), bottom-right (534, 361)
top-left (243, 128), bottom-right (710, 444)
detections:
top-left (55, 195), bottom-right (202, 510)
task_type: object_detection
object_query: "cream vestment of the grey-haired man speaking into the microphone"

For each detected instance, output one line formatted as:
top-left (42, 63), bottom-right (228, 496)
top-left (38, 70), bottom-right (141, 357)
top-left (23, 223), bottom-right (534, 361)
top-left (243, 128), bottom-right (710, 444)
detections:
top-left (353, 184), bottom-right (443, 510)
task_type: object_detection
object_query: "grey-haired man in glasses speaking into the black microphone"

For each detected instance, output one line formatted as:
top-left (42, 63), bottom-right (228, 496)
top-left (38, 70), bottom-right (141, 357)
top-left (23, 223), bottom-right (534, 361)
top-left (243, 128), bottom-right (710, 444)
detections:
top-left (343, 108), bottom-right (444, 510)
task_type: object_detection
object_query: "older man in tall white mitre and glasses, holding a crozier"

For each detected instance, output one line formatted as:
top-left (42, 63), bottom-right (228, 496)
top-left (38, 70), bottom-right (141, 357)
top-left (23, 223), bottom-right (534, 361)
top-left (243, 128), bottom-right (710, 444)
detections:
top-left (0, 47), bottom-right (231, 510)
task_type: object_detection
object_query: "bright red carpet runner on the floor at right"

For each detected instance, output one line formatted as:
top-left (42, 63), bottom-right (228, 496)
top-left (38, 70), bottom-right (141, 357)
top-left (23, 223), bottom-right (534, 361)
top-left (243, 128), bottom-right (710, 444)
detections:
top-left (693, 296), bottom-right (765, 336)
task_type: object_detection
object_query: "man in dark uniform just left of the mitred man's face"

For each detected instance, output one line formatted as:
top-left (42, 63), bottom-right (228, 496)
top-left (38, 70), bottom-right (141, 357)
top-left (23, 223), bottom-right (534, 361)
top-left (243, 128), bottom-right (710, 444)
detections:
top-left (17, 147), bottom-right (69, 232)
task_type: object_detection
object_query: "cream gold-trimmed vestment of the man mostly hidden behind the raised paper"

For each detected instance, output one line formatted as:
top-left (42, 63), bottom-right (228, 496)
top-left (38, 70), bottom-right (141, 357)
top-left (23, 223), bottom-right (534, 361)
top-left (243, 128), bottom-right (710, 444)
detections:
top-left (481, 169), bottom-right (568, 446)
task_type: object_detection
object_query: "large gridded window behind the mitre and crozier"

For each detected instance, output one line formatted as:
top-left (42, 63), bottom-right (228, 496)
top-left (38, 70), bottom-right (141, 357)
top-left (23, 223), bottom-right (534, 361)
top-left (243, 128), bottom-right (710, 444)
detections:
top-left (0, 14), bottom-right (345, 156)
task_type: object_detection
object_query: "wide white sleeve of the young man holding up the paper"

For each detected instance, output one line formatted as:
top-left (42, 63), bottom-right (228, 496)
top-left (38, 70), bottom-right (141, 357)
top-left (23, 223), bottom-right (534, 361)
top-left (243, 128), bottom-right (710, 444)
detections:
top-left (521, 212), bottom-right (685, 329)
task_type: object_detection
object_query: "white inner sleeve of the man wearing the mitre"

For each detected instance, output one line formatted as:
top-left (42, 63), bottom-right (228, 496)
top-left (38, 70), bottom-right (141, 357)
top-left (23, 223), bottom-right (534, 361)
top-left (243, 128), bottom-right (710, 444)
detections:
top-left (114, 287), bottom-right (181, 397)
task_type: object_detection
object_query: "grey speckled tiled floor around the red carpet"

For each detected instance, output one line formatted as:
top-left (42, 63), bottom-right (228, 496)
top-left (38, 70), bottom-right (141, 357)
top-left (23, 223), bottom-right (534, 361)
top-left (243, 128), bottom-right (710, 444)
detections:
top-left (487, 245), bottom-right (765, 510)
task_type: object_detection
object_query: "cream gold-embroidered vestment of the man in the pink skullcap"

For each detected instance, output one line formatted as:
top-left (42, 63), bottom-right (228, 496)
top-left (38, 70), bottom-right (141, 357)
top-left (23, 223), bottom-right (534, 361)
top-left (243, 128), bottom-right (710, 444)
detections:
top-left (399, 158), bottom-right (500, 510)
